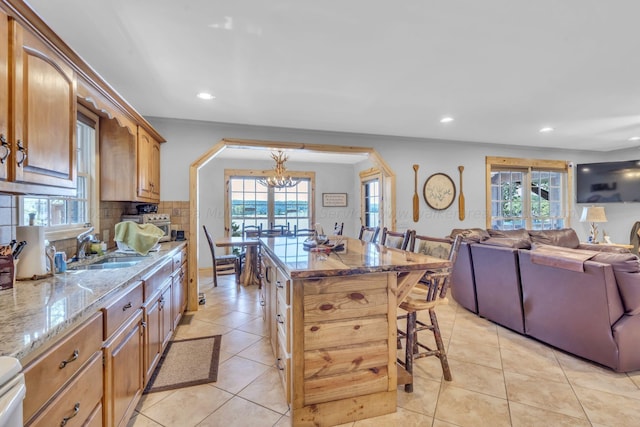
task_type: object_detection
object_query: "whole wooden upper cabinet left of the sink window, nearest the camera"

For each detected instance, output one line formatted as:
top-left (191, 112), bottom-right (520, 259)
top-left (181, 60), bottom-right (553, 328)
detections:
top-left (0, 14), bottom-right (76, 195)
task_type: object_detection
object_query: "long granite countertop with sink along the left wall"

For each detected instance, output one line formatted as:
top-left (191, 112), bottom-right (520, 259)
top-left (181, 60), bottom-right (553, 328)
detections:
top-left (0, 242), bottom-right (186, 366)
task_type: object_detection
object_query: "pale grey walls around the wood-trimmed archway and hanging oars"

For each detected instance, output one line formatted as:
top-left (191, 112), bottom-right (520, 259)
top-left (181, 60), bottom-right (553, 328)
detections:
top-left (148, 117), bottom-right (640, 262)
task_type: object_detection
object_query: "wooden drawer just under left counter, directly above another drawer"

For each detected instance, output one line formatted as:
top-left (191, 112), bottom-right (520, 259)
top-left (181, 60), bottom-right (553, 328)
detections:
top-left (23, 312), bottom-right (102, 420)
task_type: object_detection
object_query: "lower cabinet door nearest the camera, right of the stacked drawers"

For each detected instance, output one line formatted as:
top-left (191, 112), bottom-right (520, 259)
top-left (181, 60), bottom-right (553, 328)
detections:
top-left (104, 309), bottom-right (144, 426)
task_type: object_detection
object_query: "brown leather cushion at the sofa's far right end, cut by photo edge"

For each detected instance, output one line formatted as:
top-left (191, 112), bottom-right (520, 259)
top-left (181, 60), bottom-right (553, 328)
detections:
top-left (591, 252), bottom-right (640, 315)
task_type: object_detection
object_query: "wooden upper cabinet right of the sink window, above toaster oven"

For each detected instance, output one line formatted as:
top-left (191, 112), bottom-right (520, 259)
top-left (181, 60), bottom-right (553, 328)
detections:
top-left (100, 119), bottom-right (160, 203)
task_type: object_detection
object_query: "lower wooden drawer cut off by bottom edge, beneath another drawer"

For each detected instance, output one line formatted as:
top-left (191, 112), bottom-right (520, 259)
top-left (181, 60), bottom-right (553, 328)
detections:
top-left (30, 352), bottom-right (102, 427)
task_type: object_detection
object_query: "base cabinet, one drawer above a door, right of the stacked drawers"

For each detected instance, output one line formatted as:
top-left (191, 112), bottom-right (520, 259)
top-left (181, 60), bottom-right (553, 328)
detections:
top-left (102, 282), bottom-right (145, 427)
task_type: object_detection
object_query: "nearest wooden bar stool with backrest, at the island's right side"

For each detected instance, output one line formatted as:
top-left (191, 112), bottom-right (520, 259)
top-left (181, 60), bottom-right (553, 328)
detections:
top-left (398, 234), bottom-right (462, 393)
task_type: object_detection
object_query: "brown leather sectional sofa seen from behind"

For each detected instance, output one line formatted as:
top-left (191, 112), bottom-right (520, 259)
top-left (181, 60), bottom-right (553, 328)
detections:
top-left (444, 229), bottom-right (640, 372)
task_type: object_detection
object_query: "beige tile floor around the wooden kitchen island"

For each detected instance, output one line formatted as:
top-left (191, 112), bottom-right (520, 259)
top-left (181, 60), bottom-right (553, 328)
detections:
top-left (128, 274), bottom-right (640, 427)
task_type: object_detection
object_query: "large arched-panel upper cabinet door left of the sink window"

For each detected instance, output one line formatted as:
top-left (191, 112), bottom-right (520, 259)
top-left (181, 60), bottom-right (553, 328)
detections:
top-left (9, 20), bottom-right (76, 189)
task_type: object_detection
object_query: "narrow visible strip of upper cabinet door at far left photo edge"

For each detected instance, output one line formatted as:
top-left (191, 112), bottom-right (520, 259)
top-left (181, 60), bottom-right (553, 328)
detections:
top-left (0, 11), bottom-right (9, 180)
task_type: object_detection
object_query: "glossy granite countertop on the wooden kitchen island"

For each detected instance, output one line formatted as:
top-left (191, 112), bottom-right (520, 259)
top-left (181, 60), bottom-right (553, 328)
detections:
top-left (260, 237), bottom-right (449, 279)
